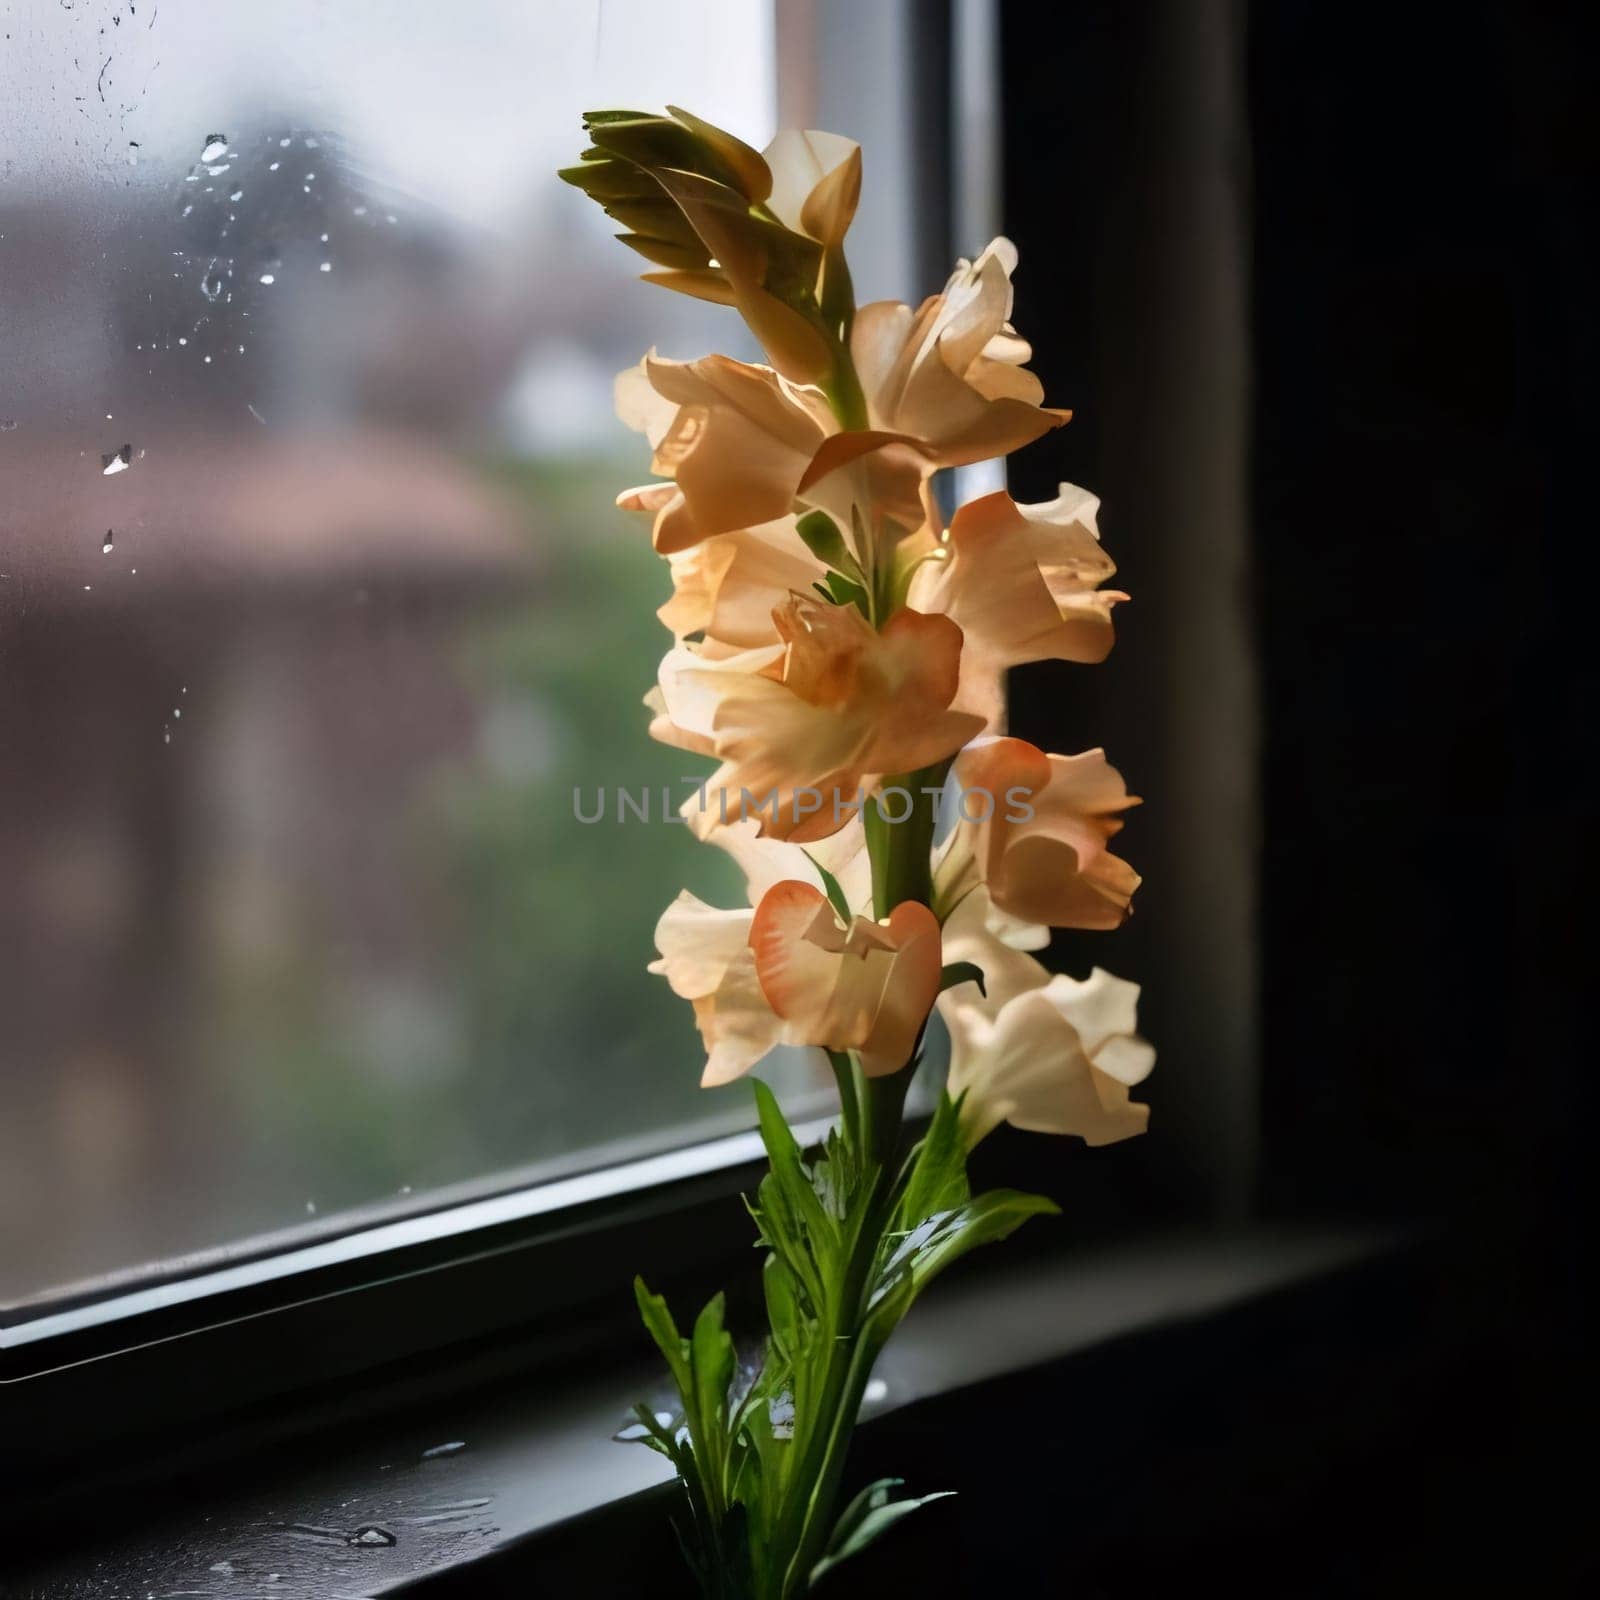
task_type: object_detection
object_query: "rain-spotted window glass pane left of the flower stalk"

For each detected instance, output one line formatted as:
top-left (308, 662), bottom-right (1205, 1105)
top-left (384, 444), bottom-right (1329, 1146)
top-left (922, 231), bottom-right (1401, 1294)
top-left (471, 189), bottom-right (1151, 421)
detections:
top-left (0, 0), bottom-right (864, 1304)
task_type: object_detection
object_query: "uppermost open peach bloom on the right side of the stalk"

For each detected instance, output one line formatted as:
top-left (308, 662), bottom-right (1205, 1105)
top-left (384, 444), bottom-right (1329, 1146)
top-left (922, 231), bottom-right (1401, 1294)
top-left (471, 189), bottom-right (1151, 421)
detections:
top-left (850, 238), bottom-right (1072, 467)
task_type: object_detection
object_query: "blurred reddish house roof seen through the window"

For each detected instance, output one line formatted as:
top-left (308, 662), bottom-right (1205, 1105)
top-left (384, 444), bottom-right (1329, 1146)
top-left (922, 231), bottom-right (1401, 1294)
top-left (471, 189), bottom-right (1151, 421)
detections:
top-left (0, 424), bottom-right (538, 606)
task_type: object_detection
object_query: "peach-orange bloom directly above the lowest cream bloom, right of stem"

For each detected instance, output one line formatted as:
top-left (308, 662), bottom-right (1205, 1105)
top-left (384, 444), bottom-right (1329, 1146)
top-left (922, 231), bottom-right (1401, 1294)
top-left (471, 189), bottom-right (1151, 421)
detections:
top-left (934, 739), bottom-right (1139, 928)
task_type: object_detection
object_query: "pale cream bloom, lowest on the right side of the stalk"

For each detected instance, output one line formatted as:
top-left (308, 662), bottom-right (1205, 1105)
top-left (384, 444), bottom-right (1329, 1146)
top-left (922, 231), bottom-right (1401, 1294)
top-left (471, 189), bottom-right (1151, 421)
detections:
top-left (939, 888), bottom-right (1155, 1147)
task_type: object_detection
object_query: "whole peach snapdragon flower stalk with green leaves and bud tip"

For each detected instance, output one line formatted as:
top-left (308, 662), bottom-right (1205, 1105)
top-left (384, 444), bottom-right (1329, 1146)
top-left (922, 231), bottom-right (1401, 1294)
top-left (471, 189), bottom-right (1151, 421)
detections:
top-left (562, 109), bottom-right (1154, 1600)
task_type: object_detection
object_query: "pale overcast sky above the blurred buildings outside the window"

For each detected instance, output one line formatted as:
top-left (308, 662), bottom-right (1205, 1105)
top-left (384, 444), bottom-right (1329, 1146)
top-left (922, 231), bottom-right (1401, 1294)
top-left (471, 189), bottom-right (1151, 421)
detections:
top-left (0, 0), bottom-right (774, 229)
